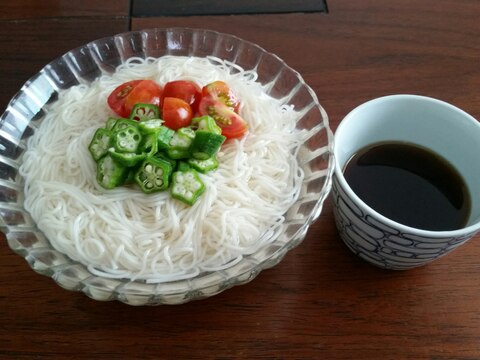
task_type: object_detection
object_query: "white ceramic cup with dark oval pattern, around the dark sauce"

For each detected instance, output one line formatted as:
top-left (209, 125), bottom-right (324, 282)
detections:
top-left (332, 95), bottom-right (480, 270)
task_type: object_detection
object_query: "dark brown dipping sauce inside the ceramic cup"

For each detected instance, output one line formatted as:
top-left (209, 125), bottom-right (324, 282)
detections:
top-left (344, 142), bottom-right (471, 231)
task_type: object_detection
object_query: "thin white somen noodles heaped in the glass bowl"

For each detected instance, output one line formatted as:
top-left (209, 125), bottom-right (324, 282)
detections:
top-left (20, 56), bottom-right (303, 282)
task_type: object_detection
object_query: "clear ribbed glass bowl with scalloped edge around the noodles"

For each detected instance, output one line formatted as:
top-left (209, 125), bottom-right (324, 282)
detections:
top-left (0, 28), bottom-right (333, 305)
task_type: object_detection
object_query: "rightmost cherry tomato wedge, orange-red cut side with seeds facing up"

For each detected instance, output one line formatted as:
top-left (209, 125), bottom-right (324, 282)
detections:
top-left (198, 96), bottom-right (248, 139)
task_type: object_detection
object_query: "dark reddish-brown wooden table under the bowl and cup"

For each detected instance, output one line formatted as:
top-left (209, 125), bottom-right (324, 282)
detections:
top-left (0, 0), bottom-right (480, 360)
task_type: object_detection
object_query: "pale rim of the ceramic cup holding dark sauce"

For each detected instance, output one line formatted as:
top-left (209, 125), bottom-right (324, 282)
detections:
top-left (333, 94), bottom-right (480, 238)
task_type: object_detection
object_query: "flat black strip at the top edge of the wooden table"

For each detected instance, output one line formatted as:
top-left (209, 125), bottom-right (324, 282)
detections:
top-left (131, 0), bottom-right (328, 17)
